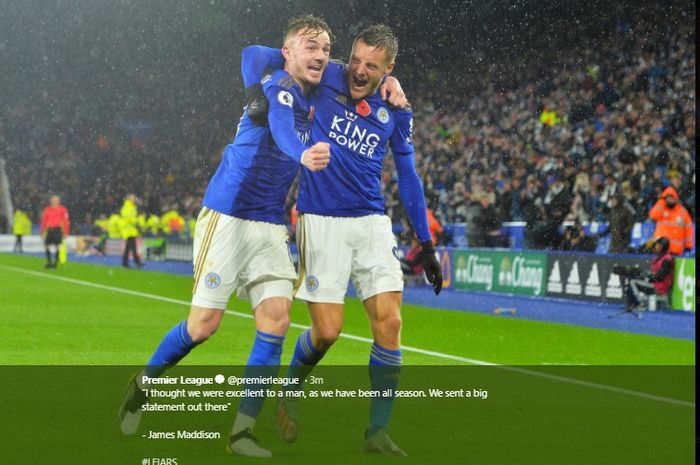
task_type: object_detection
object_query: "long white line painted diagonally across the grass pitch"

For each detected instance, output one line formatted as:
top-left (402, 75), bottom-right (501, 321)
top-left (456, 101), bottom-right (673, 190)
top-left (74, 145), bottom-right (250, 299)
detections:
top-left (0, 265), bottom-right (695, 408)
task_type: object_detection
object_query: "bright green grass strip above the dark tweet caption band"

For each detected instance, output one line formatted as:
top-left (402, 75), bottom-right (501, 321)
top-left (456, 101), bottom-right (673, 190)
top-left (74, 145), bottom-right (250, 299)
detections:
top-left (0, 254), bottom-right (695, 365)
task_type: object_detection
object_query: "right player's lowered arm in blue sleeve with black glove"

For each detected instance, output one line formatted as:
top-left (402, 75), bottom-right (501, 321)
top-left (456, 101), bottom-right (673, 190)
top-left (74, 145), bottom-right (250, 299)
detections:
top-left (390, 110), bottom-right (442, 295)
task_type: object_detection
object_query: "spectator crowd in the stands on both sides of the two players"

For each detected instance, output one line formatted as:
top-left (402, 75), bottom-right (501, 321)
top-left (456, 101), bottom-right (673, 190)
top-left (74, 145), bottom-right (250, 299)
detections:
top-left (0, 2), bottom-right (695, 248)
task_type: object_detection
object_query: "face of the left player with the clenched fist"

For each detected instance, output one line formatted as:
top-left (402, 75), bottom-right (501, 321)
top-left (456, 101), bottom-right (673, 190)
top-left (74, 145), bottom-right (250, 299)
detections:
top-left (282, 29), bottom-right (331, 91)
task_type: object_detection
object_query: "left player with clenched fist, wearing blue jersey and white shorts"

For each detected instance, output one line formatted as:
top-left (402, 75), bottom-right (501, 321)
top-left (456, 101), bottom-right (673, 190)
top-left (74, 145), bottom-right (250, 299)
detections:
top-left (119, 16), bottom-right (331, 457)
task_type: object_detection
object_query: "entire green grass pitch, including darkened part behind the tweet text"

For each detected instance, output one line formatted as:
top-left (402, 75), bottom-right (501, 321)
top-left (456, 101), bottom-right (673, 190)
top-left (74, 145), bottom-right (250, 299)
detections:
top-left (0, 254), bottom-right (695, 465)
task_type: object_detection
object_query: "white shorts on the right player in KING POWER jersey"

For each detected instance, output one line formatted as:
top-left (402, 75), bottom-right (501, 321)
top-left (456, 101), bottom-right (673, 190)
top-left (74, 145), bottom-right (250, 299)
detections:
top-left (295, 214), bottom-right (403, 304)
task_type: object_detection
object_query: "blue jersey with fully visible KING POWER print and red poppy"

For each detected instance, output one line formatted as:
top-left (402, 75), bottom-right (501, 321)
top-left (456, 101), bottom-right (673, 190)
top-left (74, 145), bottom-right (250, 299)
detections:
top-left (297, 62), bottom-right (422, 217)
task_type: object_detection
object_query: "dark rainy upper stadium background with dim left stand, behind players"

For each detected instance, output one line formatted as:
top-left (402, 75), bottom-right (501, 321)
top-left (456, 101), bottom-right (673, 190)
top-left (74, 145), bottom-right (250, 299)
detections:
top-left (0, 0), bottom-right (694, 223)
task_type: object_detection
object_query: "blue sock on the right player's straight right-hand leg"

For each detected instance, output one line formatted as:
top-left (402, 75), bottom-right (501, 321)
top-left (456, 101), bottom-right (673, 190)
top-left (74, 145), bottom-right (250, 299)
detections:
top-left (367, 342), bottom-right (401, 436)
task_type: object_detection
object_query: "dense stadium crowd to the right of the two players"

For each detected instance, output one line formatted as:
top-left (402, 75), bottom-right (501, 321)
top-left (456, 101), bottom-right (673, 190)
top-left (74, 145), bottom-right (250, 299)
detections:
top-left (384, 3), bottom-right (695, 248)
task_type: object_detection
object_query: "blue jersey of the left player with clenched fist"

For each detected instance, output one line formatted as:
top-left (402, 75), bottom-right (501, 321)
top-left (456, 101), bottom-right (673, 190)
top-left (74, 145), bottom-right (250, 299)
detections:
top-left (203, 70), bottom-right (313, 224)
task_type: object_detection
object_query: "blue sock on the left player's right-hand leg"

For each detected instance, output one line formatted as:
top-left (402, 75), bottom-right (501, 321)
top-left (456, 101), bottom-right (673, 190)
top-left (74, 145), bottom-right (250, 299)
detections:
top-left (238, 331), bottom-right (284, 418)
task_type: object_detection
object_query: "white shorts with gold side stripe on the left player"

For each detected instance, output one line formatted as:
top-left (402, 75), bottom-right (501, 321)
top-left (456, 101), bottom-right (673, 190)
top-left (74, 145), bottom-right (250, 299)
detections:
top-left (192, 207), bottom-right (297, 310)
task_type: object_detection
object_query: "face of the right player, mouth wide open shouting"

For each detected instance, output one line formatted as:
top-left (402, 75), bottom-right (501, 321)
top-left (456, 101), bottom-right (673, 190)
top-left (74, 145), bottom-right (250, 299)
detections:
top-left (348, 40), bottom-right (394, 100)
